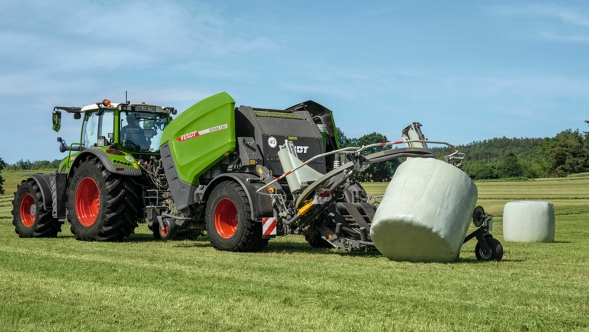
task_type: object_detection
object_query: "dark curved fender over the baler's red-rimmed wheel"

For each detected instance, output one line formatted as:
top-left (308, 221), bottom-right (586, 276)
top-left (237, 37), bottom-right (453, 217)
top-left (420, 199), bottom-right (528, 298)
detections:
top-left (202, 173), bottom-right (273, 221)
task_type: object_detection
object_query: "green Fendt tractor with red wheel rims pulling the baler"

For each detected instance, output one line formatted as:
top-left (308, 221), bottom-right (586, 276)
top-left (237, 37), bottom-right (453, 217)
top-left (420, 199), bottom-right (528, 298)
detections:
top-left (12, 99), bottom-right (176, 241)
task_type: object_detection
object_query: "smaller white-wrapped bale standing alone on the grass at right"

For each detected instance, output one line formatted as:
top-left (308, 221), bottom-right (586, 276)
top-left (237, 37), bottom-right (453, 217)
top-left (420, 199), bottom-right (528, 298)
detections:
top-left (503, 201), bottom-right (555, 242)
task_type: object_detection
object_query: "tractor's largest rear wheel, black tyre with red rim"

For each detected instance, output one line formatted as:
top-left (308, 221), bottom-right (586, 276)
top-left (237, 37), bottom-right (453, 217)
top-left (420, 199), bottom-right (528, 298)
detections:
top-left (67, 156), bottom-right (140, 241)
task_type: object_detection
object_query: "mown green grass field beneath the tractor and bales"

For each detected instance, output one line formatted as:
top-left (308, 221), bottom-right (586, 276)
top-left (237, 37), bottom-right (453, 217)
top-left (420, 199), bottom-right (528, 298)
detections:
top-left (0, 172), bottom-right (589, 331)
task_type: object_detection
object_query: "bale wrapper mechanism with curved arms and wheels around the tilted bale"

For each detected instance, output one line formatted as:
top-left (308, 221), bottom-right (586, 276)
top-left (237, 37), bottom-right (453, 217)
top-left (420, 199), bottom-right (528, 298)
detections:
top-left (257, 128), bottom-right (502, 260)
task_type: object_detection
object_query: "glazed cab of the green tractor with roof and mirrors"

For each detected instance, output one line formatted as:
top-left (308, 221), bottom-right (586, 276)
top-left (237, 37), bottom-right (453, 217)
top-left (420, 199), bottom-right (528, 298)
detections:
top-left (53, 99), bottom-right (176, 155)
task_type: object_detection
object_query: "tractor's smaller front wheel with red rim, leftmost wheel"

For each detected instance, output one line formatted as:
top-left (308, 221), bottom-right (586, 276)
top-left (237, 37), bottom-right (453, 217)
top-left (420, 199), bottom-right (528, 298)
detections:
top-left (12, 179), bottom-right (62, 238)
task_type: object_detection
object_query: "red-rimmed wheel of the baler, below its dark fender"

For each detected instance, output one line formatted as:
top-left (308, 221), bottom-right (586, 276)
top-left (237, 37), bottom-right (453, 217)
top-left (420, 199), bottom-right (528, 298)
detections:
top-left (205, 181), bottom-right (268, 251)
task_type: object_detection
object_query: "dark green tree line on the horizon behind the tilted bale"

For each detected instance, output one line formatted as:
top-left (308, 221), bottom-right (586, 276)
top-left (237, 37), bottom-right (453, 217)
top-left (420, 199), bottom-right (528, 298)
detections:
top-left (338, 128), bottom-right (589, 181)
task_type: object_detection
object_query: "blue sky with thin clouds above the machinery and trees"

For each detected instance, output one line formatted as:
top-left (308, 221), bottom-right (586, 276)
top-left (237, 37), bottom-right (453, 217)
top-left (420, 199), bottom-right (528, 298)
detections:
top-left (0, 0), bottom-right (589, 163)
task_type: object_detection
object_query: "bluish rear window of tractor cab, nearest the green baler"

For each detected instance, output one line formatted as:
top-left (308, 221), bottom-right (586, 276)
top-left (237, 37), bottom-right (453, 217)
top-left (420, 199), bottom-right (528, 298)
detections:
top-left (119, 111), bottom-right (168, 152)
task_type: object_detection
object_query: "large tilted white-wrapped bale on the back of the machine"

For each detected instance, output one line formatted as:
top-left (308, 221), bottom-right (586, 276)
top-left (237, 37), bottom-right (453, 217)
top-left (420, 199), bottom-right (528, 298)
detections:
top-left (370, 158), bottom-right (478, 262)
